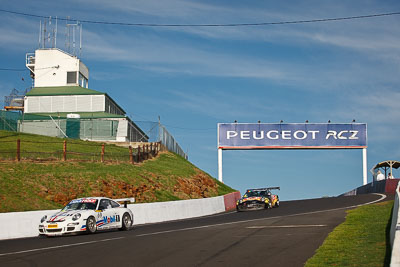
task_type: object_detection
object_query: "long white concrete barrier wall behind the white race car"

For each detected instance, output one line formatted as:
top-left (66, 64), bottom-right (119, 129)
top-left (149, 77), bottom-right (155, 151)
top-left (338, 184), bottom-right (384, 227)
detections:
top-left (0, 192), bottom-right (240, 240)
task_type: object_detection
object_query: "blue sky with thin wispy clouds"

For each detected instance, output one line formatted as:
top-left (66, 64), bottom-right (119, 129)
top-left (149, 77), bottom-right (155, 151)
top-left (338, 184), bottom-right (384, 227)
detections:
top-left (0, 0), bottom-right (400, 200)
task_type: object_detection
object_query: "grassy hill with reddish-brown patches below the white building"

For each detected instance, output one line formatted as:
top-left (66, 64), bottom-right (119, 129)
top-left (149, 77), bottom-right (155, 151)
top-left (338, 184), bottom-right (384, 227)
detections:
top-left (0, 131), bottom-right (235, 212)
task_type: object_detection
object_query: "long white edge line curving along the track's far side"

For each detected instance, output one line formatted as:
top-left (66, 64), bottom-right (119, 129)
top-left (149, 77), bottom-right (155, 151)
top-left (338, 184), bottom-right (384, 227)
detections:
top-left (136, 193), bottom-right (386, 237)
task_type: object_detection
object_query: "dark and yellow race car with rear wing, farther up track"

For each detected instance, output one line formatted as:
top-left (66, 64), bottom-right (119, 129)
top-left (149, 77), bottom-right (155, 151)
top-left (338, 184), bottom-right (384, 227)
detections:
top-left (236, 187), bottom-right (280, 211)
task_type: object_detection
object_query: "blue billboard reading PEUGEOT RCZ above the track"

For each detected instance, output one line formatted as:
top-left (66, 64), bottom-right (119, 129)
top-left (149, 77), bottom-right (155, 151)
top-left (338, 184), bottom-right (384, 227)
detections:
top-left (218, 123), bottom-right (367, 149)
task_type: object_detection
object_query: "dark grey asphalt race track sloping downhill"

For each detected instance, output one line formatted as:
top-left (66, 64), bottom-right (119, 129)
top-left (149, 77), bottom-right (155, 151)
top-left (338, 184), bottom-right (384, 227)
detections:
top-left (0, 194), bottom-right (385, 267)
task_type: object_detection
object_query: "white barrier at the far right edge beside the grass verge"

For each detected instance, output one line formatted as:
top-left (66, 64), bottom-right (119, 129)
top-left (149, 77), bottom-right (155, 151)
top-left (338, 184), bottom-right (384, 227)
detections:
top-left (390, 183), bottom-right (400, 267)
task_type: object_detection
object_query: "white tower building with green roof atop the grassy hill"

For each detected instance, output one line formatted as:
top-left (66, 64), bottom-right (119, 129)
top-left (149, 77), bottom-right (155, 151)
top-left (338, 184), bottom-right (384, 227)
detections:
top-left (19, 48), bottom-right (148, 142)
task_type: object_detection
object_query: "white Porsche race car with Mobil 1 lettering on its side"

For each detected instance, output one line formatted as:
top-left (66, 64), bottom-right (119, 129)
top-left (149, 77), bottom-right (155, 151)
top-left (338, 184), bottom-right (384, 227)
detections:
top-left (39, 197), bottom-right (135, 236)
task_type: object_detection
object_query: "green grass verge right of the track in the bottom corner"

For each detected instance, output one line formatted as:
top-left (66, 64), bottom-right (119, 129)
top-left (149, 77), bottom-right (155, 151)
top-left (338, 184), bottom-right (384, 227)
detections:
top-left (305, 201), bottom-right (393, 267)
